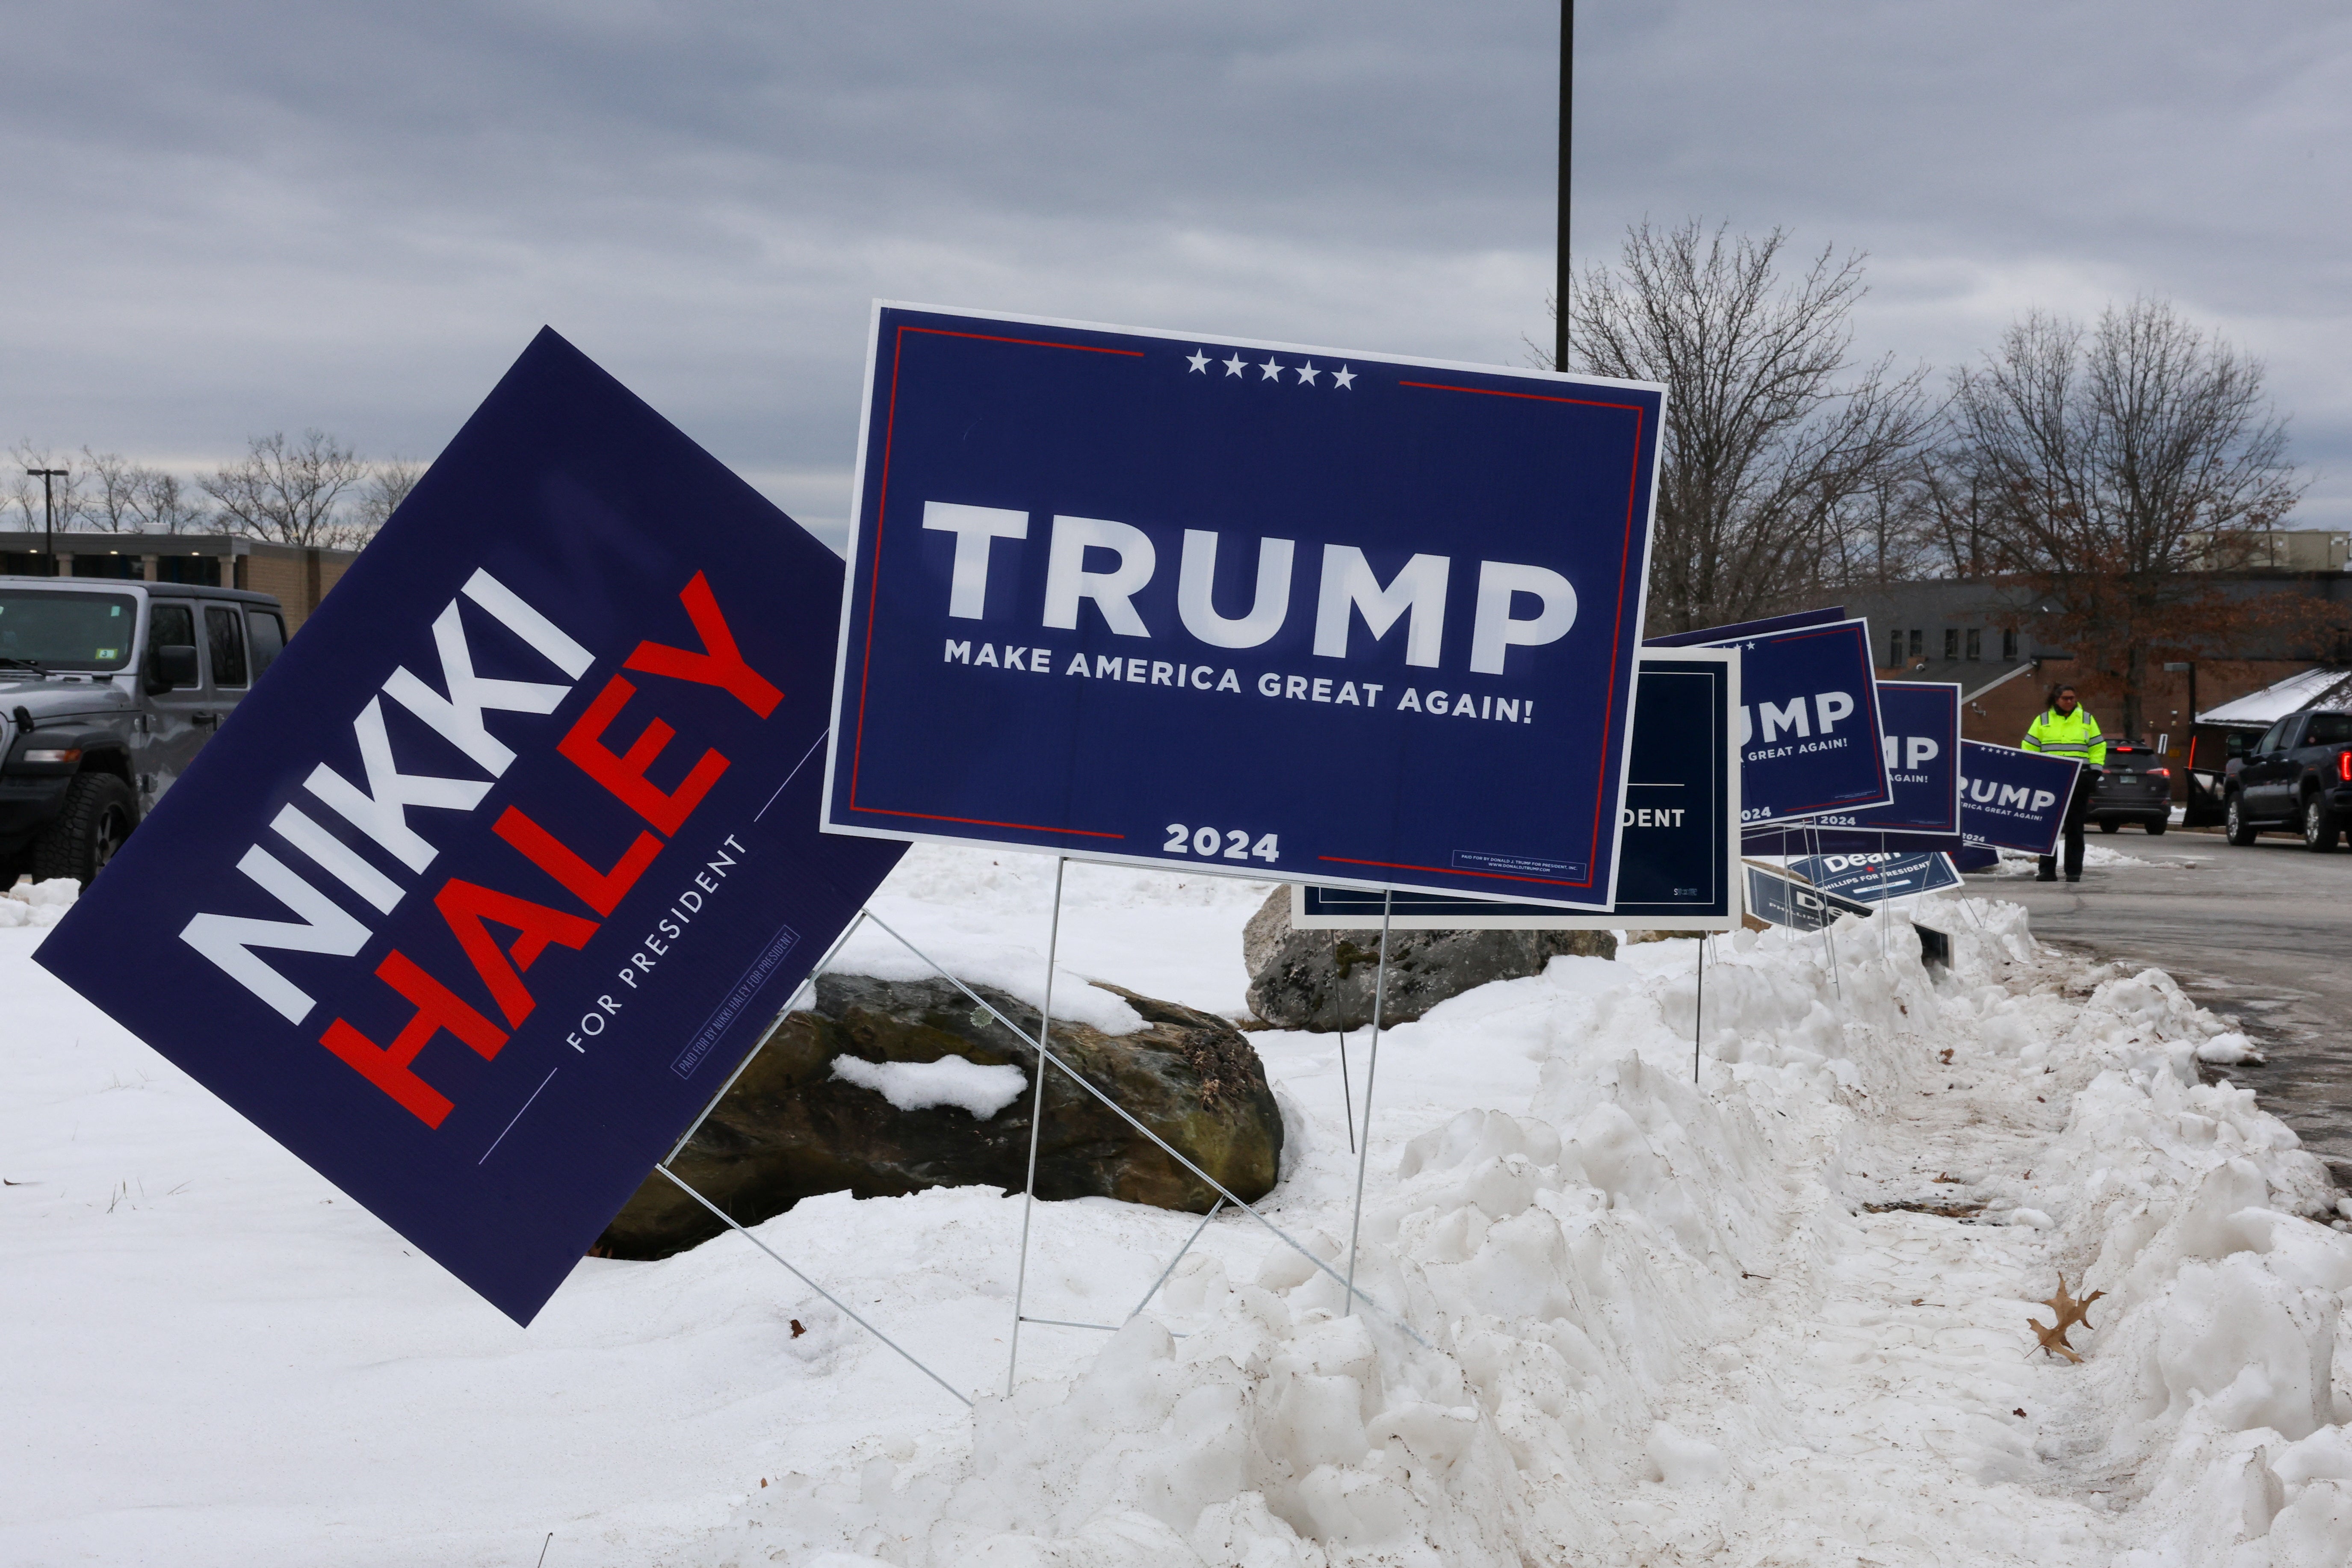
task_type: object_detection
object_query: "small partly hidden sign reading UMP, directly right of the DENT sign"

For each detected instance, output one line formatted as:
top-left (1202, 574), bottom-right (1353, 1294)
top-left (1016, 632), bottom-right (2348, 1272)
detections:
top-left (1693, 616), bottom-right (1891, 827)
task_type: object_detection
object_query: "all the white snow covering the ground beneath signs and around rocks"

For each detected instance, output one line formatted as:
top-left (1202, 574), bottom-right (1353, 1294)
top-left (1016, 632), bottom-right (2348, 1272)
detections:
top-left (0, 849), bottom-right (2352, 1568)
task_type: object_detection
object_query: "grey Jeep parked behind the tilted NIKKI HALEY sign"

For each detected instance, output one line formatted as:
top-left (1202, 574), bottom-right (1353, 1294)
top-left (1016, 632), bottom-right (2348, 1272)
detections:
top-left (0, 576), bottom-right (287, 884)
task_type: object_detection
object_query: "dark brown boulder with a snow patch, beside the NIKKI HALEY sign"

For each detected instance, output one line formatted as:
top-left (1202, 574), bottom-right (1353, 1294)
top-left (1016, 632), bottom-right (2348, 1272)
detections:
top-left (597, 976), bottom-right (1282, 1258)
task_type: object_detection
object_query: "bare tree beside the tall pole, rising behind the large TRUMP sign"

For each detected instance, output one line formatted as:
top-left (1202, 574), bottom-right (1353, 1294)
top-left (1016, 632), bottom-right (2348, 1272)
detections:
top-left (1571, 221), bottom-right (1933, 632)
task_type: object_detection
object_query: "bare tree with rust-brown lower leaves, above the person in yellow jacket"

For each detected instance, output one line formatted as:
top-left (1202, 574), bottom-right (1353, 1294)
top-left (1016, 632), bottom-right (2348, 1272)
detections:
top-left (1952, 298), bottom-right (2317, 733)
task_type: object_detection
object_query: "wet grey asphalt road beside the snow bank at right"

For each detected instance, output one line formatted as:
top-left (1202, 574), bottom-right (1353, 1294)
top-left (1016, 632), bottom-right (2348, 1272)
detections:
top-left (1969, 827), bottom-right (2352, 1187)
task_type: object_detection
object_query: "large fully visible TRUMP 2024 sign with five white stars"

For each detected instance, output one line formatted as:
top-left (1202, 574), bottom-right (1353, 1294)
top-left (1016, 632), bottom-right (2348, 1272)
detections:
top-left (826, 306), bottom-right (1663, 907)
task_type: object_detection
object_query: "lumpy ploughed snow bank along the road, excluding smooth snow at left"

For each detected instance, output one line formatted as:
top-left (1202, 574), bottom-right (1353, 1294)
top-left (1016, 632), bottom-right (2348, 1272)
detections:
top-left (706, 901), bottom-right (2352, 1568)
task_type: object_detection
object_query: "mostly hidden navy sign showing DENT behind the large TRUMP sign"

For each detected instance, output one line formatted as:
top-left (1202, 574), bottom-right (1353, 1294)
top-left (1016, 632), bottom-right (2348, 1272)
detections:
top-left (1291, 649), bottom-right (1740, 931)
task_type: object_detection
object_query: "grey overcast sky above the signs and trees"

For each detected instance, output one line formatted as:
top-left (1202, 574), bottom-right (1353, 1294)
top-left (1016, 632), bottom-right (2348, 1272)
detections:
top-left (0, 0), bottom-right (2352, 552)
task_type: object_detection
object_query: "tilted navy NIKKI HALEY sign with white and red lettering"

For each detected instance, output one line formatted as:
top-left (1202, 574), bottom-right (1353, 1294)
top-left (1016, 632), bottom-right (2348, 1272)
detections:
top-left (38, 331), bottom-right (901, 1323)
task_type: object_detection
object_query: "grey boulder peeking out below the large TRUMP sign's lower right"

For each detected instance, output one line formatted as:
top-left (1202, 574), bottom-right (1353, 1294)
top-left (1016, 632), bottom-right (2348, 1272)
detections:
top-left (1242, 886), bottom-right (1616, 1030)
